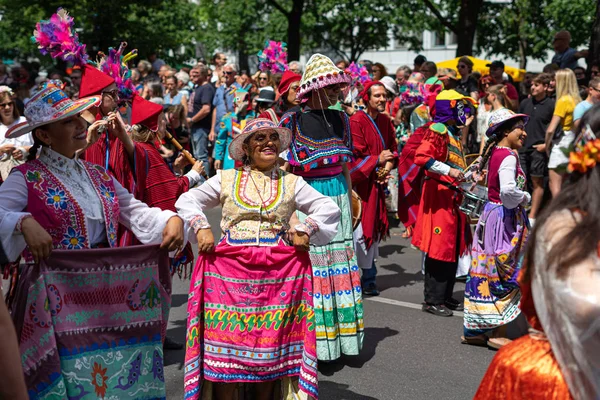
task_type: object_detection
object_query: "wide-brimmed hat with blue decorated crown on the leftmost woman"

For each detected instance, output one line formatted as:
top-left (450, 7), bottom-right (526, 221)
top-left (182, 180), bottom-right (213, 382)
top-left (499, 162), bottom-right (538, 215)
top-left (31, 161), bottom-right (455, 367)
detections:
top-left (6, 81), bottom-right (100, 139)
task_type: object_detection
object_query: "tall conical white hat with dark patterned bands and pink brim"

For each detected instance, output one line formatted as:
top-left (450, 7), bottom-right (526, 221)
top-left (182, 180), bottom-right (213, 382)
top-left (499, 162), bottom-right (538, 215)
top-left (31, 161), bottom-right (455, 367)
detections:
top-left (298, 53), bottom-right (352, 99)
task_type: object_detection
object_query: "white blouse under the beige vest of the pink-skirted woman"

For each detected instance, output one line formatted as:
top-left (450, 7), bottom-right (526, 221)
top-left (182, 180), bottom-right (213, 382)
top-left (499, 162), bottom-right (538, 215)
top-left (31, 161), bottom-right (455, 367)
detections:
top-left (175, 170), bottom-right (341, 245)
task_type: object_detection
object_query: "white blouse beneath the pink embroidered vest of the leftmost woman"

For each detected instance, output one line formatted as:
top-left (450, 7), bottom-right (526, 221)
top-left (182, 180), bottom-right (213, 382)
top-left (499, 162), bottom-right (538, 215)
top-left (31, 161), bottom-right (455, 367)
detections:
top-left (0, 147), bottom-right (187, 261)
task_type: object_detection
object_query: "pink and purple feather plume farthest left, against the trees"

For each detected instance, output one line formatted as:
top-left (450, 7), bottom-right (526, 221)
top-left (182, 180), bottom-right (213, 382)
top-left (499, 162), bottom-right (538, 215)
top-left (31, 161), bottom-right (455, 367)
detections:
top-left (31, 8), bottom-right (89, 67)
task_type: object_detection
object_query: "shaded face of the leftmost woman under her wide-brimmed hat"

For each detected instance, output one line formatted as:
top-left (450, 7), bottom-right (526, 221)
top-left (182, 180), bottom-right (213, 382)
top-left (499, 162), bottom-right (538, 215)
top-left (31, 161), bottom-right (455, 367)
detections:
top-left (35, 115), bottom-right (87, 158)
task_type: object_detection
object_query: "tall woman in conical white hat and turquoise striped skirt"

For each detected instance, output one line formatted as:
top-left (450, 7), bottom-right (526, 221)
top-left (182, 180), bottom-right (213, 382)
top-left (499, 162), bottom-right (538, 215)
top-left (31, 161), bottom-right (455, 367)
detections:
top-left (280, 54), bottom-right (364, 361)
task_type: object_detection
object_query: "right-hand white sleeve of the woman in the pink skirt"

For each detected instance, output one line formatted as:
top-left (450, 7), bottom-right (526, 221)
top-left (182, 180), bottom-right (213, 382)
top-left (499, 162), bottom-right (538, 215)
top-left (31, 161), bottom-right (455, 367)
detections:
top-left (295, 177), bottom-right (341, 245)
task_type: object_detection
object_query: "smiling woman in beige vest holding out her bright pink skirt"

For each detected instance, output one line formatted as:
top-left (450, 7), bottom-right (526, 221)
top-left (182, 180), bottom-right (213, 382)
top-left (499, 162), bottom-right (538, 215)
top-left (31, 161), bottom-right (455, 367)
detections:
top-left (176, 119), bottom-right (340, 400)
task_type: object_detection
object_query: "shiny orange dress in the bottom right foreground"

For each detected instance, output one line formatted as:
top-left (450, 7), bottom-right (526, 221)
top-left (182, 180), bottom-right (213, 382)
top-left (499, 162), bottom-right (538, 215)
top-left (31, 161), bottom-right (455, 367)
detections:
top-left (474, 275), bottom-right (573, 400)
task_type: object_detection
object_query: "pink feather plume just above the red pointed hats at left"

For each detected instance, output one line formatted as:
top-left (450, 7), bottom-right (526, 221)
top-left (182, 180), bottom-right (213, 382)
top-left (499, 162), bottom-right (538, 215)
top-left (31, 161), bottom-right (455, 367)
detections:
top-left (97, 42), bottom-right (137, 100)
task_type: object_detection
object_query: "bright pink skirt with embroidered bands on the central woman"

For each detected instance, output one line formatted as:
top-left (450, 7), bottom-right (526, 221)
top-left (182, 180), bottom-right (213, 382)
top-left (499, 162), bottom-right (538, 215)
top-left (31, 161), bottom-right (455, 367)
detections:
top-left (184, 243), bottom-right (317, 399)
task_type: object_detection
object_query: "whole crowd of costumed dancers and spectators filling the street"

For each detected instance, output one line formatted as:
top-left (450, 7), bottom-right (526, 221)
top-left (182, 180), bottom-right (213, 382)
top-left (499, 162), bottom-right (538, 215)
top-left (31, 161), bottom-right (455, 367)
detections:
top-left (0, 9), bottom-right (600, 400)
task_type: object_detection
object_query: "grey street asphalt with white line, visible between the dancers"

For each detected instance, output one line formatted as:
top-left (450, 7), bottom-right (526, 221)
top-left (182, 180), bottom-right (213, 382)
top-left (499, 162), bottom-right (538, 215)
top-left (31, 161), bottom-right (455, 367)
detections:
top-left (165, 210), bottom-right (526, 400)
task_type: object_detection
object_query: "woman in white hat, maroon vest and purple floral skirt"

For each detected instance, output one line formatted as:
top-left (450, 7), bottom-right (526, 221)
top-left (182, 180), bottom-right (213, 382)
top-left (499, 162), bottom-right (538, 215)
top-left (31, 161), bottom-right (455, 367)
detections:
top-left (461, 108), bottom-right (531, 349)
